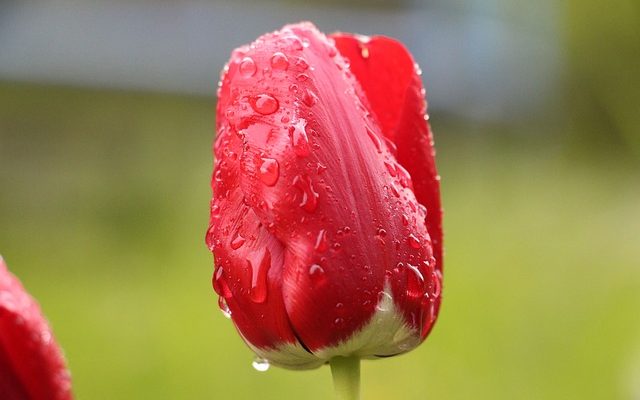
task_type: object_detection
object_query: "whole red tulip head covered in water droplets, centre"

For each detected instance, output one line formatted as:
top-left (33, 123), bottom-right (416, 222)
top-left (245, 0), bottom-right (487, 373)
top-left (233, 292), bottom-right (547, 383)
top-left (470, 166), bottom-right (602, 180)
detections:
top-left (207, 23), bottom-right (442, 369)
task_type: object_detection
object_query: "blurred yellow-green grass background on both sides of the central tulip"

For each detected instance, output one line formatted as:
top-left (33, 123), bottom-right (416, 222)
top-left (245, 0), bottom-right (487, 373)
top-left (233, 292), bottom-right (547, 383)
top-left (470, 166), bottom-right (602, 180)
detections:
top-left (0, 83), bottom-right (640, 400)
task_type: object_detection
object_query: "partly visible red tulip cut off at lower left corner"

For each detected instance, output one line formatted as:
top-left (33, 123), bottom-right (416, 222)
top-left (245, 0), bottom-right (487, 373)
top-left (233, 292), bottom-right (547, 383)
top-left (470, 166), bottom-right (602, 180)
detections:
top-left (0, 257), bottom-right (72, 400)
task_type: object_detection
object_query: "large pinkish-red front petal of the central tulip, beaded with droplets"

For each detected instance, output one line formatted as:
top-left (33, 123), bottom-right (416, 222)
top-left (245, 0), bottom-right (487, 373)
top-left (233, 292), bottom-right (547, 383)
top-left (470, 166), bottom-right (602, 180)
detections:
top-left (209, 24), bottom-right (433, 356)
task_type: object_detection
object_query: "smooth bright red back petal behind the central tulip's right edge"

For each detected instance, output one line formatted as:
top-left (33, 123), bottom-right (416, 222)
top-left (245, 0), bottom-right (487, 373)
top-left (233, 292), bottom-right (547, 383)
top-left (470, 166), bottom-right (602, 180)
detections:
top-left (331, 33), bottom-right (442, 338)
